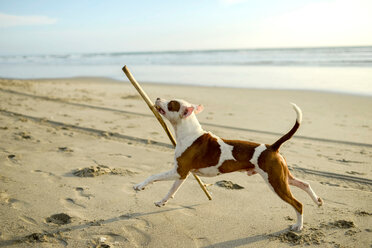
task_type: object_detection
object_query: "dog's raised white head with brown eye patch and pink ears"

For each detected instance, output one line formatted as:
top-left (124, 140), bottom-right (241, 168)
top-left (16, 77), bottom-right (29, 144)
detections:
top-left (155, 98), bottom-right (204, 123)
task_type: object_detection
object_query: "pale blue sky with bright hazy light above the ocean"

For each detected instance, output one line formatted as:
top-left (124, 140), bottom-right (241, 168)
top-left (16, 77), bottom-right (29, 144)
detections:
top-left (0, 0), bottom-right (372, 55)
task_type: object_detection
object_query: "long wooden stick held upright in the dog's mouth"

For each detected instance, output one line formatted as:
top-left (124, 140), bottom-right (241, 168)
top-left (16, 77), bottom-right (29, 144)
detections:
top-left (123, 65), bottom-right (212, 200)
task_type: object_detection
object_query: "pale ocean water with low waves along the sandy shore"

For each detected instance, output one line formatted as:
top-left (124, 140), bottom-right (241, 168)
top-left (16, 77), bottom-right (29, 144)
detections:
top-left (0, 46), bottom-right (372, 96)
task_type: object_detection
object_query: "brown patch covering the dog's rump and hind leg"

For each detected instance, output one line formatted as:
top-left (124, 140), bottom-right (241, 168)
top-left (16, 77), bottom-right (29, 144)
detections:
top-left (258, 147), bottom-right (303, 214)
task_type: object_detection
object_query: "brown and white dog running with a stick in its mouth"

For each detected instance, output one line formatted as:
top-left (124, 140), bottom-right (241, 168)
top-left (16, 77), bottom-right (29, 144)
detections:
top-left (134, 98), bottom-right (323, 231)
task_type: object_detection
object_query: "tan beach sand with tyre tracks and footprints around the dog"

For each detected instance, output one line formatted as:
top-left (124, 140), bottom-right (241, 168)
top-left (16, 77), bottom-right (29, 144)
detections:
top-left (0, 78), bottom-right (372, 247)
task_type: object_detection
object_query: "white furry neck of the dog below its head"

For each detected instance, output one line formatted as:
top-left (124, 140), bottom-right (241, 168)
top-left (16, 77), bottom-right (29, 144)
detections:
top-left (172, 113), bottom-right (205, 143)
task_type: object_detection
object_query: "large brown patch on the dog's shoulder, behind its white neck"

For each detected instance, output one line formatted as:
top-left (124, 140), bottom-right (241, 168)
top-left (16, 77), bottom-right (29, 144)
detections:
top-left (177, 133), bottom-right (221, 179)
